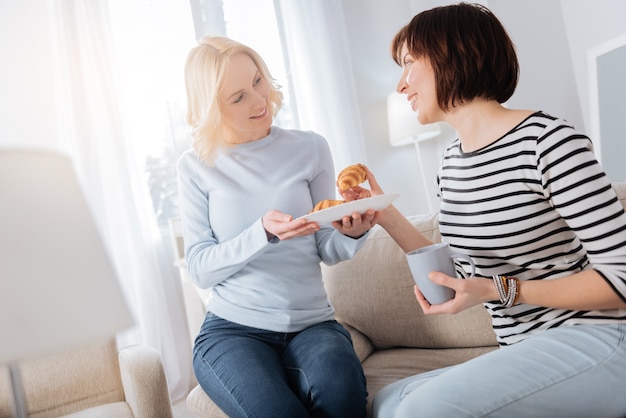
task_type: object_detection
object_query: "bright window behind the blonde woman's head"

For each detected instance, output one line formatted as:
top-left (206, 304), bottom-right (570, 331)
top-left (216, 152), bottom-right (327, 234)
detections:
top-left (109, 0), bottom-right (294, 231)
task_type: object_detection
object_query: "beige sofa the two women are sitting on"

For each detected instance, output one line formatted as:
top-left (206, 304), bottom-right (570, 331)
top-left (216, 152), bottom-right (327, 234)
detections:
top-left (178, 183), bottom-right (626, 417)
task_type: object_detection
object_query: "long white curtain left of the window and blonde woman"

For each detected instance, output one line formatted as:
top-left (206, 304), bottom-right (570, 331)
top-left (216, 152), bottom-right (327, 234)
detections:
top-left (48, 0), bottom-right (191, 400)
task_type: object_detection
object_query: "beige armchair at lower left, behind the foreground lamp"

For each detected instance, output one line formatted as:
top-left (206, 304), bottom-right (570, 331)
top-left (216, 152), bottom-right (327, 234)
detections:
top-left (0, 339), bottom-right (173, 418)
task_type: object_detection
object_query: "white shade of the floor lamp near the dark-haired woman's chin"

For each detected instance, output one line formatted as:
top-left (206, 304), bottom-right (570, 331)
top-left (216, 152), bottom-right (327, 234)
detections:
top-left (387, 92), bottom-right (442, 147)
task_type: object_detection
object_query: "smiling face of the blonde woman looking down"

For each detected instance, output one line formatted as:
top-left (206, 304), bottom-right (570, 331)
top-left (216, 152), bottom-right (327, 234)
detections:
top-left (218, 54), bottom-right (272, 143)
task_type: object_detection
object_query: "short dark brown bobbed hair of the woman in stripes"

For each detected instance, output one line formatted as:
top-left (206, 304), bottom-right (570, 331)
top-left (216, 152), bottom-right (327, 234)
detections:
top-left (391, 3), bottom-right (519, 111)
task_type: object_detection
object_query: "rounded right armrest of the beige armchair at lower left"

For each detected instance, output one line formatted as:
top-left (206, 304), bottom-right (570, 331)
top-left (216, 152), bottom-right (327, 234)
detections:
top-left (118, 345), bottom-right (173, 418)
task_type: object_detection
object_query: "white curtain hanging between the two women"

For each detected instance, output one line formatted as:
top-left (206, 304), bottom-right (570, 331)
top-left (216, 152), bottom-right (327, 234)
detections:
top-left (274, 0), bottom-right (367, 171)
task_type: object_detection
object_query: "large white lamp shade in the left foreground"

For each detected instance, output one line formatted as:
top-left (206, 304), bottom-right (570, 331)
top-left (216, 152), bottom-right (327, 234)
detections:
top-left (0, 150), bottom-right (132, 363)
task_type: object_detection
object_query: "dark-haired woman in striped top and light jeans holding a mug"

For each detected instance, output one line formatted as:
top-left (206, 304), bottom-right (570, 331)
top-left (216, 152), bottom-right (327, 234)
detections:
top-left (356, 3), bottom-right (626, 418)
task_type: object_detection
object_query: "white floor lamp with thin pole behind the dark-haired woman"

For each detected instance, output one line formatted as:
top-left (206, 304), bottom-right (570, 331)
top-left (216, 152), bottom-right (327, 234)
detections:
top-left (387, 92), bottom-right (443, 211)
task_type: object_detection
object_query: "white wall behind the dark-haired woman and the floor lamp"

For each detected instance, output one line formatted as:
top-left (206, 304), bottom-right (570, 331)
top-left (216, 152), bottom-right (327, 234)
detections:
top-left (342, 0), bottom-right (626, 215)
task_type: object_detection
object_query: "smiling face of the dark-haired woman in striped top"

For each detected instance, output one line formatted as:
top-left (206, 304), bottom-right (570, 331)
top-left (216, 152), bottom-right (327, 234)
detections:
top-left (396, 44), bottom-right (443, 125)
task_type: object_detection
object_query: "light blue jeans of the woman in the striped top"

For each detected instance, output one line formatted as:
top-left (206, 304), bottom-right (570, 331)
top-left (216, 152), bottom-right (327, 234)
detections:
top-left (373, 324), bottom-right (626, 418)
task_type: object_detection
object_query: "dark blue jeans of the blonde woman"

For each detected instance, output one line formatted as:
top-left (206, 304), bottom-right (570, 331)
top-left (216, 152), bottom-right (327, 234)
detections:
top-left (193, 313), bottom-right (367, 418)
